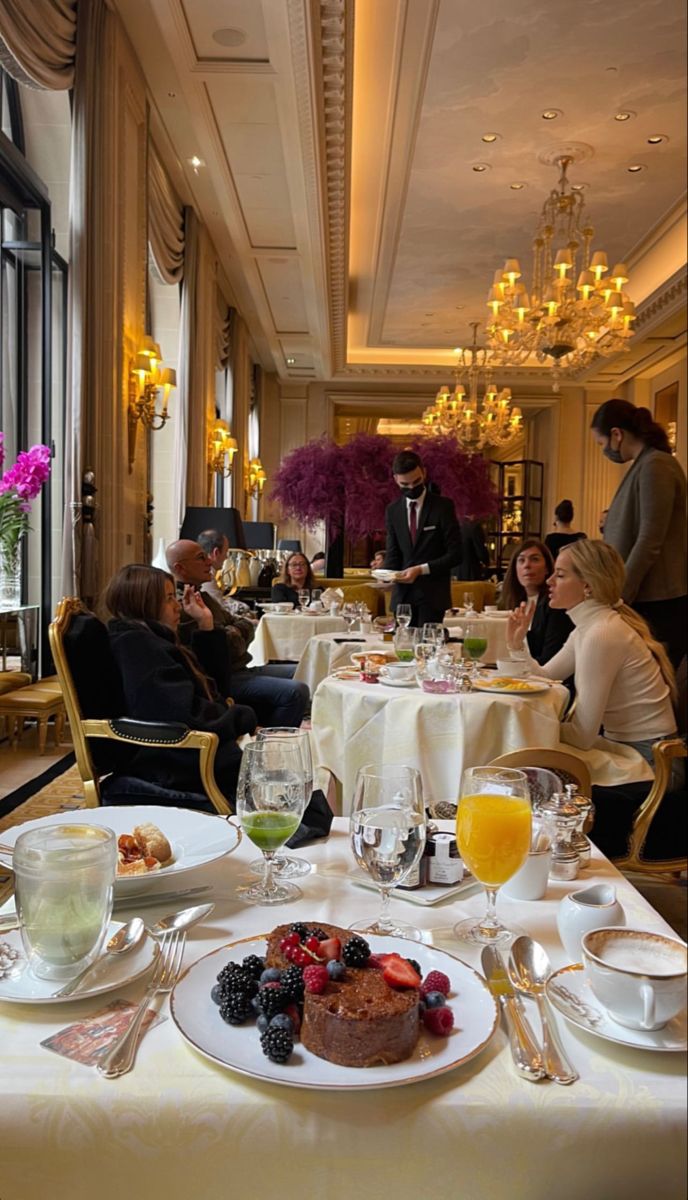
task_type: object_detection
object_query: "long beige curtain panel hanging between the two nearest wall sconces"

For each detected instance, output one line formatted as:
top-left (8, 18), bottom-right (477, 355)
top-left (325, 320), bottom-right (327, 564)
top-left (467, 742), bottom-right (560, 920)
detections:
top-left (174, 209), bottom-right (216, 526)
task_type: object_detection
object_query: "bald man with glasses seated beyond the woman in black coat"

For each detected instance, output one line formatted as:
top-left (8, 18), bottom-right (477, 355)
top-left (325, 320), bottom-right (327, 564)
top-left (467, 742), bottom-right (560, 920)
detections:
top-left (166, 538), bottom-right (311, 727)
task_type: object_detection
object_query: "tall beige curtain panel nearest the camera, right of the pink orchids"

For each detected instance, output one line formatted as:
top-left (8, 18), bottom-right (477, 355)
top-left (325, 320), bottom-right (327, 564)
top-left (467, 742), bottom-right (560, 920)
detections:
top-left (62, 0), bottom-right (118, 595)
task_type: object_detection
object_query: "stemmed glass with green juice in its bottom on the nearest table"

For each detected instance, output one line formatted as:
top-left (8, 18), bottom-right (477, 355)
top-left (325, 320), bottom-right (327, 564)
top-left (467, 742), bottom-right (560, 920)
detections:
top-left (237, 738), bottom-right (306, 905)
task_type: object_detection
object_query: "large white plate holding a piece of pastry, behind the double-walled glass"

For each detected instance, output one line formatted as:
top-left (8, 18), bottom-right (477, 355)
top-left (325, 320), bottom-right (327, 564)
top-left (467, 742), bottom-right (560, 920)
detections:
top-left (2, 804), bottom-right (241, 896)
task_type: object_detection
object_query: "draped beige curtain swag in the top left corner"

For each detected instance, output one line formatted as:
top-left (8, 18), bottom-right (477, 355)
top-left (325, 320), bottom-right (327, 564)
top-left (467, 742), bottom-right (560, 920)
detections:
top-left (0, 0), bottom-right (75, 91)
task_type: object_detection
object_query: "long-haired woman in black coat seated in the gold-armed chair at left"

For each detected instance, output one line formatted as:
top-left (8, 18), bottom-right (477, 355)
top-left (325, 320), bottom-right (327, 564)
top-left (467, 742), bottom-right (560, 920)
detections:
top-left (104, 564), bottom-right (256, 800)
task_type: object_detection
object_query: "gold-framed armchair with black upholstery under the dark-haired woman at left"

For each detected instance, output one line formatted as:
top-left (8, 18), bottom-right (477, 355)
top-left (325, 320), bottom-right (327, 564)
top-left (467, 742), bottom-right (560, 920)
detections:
top-left (48, 596), bottom-right (232, 816)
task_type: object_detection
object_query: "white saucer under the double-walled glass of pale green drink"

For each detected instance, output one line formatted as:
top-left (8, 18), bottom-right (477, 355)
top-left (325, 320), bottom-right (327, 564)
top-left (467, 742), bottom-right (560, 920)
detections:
top-left (0, 920), bottom-right (158, 1004)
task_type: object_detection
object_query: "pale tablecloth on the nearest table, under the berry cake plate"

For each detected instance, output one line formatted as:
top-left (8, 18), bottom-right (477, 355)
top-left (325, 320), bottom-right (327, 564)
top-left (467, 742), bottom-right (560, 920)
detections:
top-left (0, 821), bottom-right (686, 1200)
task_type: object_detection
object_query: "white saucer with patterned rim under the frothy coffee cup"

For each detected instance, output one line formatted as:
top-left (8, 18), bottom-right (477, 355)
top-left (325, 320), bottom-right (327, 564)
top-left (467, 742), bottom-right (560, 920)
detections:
top-left (545, 962), bottom-right (688, 1052)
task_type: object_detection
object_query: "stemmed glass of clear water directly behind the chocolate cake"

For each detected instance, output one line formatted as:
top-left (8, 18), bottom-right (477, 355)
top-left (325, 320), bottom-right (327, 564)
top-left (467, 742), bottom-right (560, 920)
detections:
top-left (349, 763), bottom-right (425, 941)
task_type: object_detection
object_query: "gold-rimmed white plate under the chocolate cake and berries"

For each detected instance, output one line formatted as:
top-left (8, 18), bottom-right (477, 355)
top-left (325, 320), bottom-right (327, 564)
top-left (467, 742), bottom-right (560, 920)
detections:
top-left (169, 935), bottom-right (497, 1091)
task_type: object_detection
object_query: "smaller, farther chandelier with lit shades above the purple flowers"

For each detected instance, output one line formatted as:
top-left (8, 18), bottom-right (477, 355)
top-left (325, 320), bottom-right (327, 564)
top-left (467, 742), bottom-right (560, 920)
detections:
top-left (421, 320), bottom-right (522, 454)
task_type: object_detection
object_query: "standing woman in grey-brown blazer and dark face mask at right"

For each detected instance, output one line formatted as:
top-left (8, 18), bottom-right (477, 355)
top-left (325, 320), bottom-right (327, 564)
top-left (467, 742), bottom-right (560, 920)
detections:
top-left (591, 400), bottom-right (688, 667)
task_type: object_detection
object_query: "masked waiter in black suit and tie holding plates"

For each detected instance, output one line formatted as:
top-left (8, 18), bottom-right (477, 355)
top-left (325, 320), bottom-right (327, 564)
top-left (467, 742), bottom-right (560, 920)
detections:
top-left (384, 450), bottom-right (461, 626)
